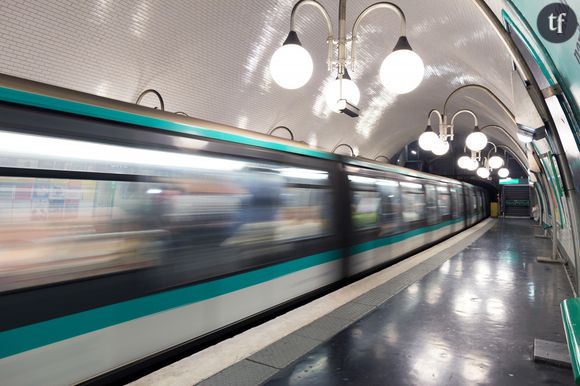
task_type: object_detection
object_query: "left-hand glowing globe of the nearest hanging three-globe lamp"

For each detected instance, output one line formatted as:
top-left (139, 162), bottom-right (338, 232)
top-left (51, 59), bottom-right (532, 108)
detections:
top-left (270, 31), bottom-right (313, 90)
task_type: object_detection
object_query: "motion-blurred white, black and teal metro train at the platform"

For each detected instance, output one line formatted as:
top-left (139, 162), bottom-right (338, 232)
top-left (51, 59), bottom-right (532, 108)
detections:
top-left (0, 76), bottom-right (488, 385)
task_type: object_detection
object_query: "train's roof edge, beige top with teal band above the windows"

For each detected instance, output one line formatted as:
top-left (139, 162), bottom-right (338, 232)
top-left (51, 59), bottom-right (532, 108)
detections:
top-left (0, 74), bottom-right (480, 190)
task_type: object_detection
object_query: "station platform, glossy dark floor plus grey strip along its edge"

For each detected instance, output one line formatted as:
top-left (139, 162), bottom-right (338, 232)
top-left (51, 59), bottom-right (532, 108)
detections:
top-left (135, 219), bottom-right (573, 386)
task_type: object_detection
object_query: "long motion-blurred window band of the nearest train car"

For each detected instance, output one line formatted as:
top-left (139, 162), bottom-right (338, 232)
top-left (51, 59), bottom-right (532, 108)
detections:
top-left (0, 133), bottom-right (332, 291)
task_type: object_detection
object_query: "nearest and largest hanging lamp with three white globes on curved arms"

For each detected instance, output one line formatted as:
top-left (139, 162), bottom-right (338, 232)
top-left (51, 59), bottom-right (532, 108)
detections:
top-left (270, 0), bottom-right (425, 117)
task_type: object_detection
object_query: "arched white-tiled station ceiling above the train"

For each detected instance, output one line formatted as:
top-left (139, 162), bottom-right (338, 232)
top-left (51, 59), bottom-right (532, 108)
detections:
top-left (0, 0), bottom-right (541, 166)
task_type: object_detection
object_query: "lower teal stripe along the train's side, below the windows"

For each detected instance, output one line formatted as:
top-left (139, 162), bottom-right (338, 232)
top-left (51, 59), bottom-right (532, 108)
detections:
top-left (0, 218), bottom-right (474, 358)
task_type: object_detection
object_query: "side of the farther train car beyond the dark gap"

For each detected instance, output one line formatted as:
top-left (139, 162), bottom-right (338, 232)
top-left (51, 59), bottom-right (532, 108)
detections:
top-left (344, 159), bottom-right (472, 275)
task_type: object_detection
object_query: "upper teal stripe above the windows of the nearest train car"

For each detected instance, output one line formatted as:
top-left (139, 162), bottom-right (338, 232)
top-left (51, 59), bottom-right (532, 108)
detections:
top-left (0, 87), bottom-right (336, 160)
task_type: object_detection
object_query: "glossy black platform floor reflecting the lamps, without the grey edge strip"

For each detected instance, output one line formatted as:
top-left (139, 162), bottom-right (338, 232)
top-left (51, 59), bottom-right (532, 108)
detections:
top-left (266, 219), bottom-right (573, 385)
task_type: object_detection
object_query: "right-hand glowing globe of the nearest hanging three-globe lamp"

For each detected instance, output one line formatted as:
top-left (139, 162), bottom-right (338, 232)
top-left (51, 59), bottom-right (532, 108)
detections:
top-left (379, 36), bottom-right (425, 94)
